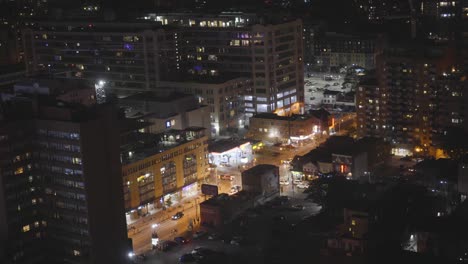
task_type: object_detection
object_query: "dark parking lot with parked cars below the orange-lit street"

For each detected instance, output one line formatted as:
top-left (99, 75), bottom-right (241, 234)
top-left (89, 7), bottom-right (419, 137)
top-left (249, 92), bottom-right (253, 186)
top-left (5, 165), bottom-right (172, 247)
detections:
top-left (136, 195), bottom-right (321, 264)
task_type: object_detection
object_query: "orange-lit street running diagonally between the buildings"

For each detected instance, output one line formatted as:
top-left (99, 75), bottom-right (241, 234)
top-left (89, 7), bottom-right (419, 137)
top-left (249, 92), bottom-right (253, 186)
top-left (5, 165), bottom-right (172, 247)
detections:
top-left (129, 117), bottom-right (353, 256)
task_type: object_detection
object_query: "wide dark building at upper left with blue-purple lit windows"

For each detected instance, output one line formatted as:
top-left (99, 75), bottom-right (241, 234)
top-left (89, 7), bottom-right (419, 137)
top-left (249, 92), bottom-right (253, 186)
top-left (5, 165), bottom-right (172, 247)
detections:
top-left (23, 22), bottom-right (175, 94)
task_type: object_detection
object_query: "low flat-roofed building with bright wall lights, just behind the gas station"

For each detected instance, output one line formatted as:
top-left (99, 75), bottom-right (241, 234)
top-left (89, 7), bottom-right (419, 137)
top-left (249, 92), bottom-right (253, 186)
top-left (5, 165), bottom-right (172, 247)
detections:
top-left (247, 113), bottom-right (320, 143)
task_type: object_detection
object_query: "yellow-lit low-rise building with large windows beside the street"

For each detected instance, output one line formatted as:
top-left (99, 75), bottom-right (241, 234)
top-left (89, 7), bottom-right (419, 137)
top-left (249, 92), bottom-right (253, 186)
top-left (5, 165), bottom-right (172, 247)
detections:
top-left (121, 127), bottom-right (208, 217)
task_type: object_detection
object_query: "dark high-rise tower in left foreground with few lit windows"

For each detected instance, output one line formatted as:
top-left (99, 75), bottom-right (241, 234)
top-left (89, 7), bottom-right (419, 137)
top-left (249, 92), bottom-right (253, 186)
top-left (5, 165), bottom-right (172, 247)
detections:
top-left (0, 82), bottom-right (130, 263)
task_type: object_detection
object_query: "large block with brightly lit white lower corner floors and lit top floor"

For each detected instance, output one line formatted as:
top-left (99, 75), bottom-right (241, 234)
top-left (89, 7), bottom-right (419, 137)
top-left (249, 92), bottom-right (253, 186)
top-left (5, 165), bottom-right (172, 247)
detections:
top-left (156, 13), bottom-right (304, 117)
